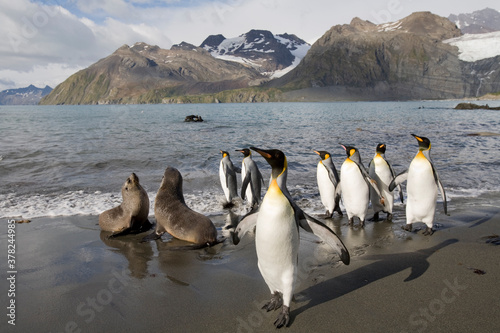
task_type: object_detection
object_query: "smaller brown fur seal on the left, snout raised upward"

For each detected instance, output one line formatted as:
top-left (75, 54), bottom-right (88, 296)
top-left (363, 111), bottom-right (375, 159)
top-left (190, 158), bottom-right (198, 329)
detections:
top-left (99, 173), bottom-right (151, 237)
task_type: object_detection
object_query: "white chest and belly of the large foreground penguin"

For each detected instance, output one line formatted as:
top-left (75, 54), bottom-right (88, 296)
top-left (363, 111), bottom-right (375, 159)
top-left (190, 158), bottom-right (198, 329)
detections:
top-left (255, 180), bottom-right (299, 293)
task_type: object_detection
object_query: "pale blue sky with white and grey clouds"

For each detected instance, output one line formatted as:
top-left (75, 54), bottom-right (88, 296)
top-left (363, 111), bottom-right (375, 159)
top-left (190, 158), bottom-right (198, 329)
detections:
top-left (0, 0), bottom-right (500, 91)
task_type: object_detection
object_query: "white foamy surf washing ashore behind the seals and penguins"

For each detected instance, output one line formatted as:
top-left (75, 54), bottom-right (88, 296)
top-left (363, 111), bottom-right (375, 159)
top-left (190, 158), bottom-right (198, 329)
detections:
top-left (0, 186), bottom-right (500, 219)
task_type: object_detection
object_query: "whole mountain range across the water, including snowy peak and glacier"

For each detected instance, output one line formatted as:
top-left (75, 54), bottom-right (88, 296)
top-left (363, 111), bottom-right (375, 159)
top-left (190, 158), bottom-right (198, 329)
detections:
top-left (40, 12), bottom-right (500, 104)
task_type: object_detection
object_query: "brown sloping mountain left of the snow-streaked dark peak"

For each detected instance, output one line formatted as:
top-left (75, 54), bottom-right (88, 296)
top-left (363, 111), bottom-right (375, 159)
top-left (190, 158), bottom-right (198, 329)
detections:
top-left (40, 42), bottom-right (263, 104)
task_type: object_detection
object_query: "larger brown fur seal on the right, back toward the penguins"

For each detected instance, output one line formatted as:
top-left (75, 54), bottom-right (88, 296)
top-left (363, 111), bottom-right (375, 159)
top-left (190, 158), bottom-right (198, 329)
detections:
top-left (143, 167), bottom-right (218, 248)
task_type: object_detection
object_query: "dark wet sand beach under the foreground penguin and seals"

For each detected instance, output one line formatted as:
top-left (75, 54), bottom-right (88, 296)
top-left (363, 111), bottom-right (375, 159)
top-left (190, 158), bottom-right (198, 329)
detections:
top-left (0, 196), bottom-right (500, 332)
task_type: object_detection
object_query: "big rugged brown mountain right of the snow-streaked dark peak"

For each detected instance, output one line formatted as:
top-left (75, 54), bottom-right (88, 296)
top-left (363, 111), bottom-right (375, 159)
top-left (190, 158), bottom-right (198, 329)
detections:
top-left (266, 12), bottom-right (500, 100)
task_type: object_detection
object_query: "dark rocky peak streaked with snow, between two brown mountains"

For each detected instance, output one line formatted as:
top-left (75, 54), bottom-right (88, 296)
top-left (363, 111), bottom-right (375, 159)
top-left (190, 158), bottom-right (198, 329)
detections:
top-left (200, 30), bottom-right (311, 78)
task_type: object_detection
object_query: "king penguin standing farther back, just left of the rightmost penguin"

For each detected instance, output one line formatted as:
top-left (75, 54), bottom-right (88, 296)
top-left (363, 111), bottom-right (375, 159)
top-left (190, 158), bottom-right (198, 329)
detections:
top-left (368, 143), bottom-right (403, 221)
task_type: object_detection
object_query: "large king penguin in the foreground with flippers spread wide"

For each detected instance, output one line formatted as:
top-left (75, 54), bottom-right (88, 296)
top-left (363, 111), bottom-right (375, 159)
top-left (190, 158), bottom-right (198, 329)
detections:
top-left (233, 147), bottom-right (350, 328)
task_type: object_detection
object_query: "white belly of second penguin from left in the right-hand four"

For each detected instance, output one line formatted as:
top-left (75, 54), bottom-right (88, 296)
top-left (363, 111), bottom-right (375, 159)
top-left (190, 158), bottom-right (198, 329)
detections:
top-left (340, 160), bottom-right (370, 220)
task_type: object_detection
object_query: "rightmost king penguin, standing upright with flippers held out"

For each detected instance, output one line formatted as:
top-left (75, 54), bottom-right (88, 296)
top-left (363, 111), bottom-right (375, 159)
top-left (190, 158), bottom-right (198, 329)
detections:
top-left (389, 134), bottom-right (448, 236)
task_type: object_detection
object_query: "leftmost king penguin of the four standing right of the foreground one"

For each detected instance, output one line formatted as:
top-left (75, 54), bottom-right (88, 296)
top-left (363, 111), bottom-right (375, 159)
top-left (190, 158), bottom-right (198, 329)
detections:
top-left (314, 150), bottom-right (343, 218)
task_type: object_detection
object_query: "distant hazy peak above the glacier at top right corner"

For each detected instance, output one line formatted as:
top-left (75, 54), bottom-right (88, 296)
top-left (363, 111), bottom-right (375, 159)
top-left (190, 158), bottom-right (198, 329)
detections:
top-left (448, 8), bottom-right (500, 34)
